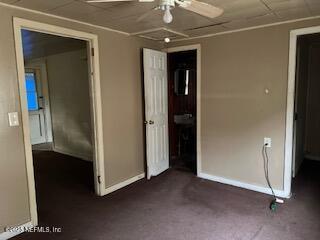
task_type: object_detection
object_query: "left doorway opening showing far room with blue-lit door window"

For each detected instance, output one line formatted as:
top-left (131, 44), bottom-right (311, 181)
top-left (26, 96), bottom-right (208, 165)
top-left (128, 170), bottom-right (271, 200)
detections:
top-left (21, 30), bottom-right (95, 230)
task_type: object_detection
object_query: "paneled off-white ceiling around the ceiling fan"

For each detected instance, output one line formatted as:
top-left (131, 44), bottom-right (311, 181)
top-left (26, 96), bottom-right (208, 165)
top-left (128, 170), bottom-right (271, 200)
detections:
top-left (0, 0), bottom-right (320, 37)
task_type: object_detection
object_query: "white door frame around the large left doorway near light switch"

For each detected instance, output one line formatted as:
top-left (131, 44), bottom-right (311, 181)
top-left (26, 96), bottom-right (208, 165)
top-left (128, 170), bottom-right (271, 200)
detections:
top-left (13, 17), bottom-right (105, 226)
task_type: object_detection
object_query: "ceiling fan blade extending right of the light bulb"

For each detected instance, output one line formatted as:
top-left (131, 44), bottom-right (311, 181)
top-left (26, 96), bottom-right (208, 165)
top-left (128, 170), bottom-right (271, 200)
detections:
top-left (179, 0), bottom-right (223, 18)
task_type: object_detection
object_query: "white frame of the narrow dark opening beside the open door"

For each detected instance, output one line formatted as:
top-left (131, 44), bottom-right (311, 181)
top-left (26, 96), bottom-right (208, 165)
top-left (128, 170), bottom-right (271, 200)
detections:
top-left (164, 44), bottom-right (202, 177)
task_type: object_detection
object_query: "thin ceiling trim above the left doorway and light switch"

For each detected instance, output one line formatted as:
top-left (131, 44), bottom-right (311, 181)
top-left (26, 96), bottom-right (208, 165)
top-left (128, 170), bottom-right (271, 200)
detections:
top-left (0, 2), bottom-right (130, 36)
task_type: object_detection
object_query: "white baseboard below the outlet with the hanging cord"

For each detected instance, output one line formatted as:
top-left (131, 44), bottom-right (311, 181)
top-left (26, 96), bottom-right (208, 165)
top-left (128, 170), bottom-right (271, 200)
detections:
top-left (198, 172), bottom-right (290, 198)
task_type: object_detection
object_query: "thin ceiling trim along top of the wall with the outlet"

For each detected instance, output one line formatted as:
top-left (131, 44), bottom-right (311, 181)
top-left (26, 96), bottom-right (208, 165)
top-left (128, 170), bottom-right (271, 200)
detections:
top-left (171, 15), bottom-right (320, 42)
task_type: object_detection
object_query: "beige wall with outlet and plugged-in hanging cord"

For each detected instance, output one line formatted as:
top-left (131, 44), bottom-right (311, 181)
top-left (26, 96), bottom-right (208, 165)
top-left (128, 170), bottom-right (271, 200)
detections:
top-left (169, 17), bottom-right (320, 190)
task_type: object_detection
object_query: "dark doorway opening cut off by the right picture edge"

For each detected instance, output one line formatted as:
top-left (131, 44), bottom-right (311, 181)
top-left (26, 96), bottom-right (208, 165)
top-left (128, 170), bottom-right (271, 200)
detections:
top-left (292, 33), bottom-right (320, 177)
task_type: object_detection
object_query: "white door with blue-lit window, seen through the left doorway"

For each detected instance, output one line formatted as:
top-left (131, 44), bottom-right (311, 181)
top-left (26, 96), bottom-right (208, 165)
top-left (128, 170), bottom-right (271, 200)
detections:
top-left (25, 69), bottom-right (46, 145)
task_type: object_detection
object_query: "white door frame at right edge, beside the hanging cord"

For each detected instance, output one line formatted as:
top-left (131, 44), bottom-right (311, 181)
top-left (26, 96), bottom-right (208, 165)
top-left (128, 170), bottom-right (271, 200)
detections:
top-left (283, 26), bottom-right (320, 197)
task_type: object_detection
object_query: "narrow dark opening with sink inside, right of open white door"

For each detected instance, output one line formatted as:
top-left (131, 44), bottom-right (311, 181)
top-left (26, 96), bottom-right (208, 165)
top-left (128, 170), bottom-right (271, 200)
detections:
top-left (168, 50), bottom-right (197, 173)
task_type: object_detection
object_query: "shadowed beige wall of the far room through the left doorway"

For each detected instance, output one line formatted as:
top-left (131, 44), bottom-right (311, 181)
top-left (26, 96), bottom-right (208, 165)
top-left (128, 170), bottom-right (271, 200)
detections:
top-left (46, 48), bottom-right (93, 161)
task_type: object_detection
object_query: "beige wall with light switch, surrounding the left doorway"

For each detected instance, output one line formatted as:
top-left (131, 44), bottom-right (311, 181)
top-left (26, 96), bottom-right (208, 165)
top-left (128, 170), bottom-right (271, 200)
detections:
top-left (0, 6), bottom-right (158, 231)
